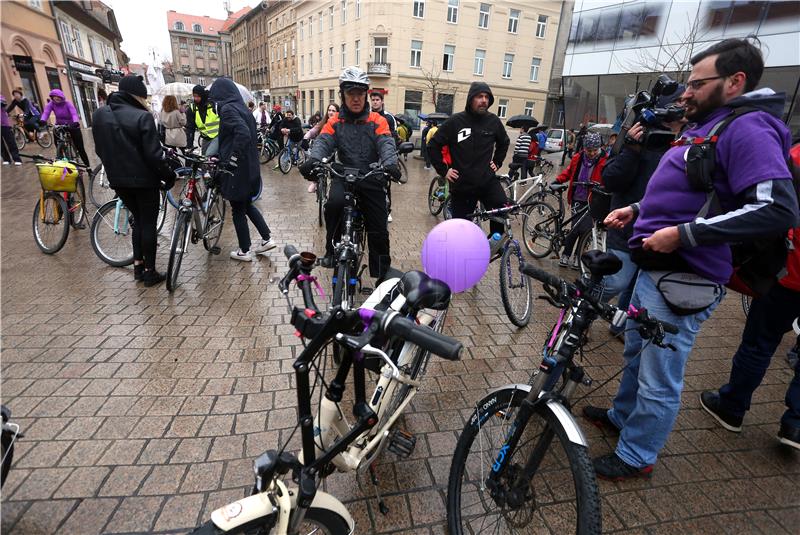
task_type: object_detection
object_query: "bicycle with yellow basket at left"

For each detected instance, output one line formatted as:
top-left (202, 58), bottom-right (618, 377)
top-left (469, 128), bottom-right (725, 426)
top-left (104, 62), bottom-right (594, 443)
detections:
top-left (20, 154), bottom-right (89, 254)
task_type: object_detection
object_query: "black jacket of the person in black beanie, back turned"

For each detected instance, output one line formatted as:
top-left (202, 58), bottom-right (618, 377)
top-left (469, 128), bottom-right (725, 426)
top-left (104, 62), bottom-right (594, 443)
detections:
top-left (92, 91), bottom-right (173, 189)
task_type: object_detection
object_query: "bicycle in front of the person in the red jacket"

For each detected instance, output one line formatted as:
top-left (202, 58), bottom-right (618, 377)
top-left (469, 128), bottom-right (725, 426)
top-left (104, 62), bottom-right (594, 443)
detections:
top-left (522, 182), bottom-right (608, 273)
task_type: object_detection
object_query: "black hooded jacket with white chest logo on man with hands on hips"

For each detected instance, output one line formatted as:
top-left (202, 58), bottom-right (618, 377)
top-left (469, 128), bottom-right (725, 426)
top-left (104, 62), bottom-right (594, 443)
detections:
top-left (428, 82), bottom-right (510, 192)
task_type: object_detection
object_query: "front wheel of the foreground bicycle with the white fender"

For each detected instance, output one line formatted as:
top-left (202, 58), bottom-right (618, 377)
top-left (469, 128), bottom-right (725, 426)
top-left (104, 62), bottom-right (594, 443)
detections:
top-left (447, 387), bottom-right (601, 535)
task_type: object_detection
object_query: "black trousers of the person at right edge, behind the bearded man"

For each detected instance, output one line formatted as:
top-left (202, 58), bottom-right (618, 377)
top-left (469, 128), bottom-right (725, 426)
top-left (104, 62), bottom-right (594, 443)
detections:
top-left (719, 284), bottom-right (800, 428)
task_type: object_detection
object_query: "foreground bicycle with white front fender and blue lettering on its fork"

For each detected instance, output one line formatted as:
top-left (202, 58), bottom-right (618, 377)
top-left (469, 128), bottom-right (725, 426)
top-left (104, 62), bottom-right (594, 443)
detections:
top-left (447, 251), bottom-right (678, 535)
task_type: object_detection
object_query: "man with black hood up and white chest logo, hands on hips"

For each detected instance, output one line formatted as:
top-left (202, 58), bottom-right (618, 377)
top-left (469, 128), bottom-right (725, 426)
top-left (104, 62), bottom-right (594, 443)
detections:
top-left (428, 82), bottom-right (510, 253)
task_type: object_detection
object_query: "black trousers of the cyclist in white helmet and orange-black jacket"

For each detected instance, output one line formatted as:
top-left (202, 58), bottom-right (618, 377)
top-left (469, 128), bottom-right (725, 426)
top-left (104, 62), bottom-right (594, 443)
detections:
top-left (325, 178), bottom-right (392, 278)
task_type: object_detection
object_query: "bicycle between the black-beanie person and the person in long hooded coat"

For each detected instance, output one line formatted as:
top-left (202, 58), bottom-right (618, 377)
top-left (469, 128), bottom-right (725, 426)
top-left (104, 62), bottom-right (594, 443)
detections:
top-left (167, 154), bottom-right (225, 292)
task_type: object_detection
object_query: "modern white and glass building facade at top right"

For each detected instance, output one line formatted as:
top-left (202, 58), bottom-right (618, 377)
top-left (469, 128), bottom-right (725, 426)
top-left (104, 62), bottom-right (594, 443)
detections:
top-left (563, 0), bottom-right (800, 136)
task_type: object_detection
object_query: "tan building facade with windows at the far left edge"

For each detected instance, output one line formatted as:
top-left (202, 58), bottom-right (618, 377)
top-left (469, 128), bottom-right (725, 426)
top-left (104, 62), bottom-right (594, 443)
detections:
top-left (0, 0), bottom-right (72, 110)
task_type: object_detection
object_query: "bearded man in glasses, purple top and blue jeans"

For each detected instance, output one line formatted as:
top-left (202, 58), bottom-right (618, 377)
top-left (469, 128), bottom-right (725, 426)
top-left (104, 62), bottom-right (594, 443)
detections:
top-left (590, 39), bottom-right (798, 481)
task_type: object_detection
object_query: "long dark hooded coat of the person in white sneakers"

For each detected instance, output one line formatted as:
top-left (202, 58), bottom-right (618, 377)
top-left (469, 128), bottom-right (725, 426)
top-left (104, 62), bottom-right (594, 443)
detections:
top-left (208, 78), bottom-right (261, 202)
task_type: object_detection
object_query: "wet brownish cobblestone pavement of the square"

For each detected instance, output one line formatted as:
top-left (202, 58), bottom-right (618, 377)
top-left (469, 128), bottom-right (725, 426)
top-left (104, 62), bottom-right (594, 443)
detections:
top-left (0, 135), bottom-right (800, 535)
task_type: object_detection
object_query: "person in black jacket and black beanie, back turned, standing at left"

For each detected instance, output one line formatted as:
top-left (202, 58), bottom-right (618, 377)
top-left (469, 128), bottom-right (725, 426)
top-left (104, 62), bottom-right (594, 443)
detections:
top-left (92, 75), bottom-right (175, 286)
